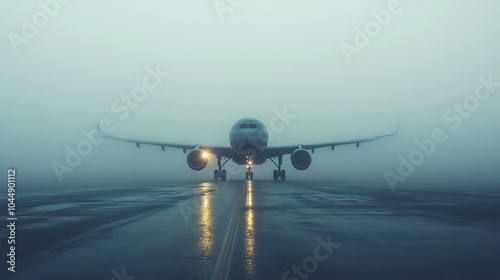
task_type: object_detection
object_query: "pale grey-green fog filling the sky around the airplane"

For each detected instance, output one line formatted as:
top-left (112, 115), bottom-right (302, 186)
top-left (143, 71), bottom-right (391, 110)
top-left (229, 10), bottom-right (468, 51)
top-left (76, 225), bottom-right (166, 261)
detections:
top-left (0, 0), bottom-right (500, 189)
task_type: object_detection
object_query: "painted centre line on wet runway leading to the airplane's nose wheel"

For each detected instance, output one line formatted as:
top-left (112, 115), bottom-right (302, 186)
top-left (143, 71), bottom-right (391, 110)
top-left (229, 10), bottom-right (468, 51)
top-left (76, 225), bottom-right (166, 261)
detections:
top-left (214, 181), bottom-right (247, 280)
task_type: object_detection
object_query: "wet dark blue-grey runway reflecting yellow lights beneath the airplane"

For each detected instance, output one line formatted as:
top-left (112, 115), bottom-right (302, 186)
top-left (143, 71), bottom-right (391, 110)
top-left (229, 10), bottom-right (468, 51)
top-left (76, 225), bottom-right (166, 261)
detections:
top-left (0, 181), bottom-right (500, 280)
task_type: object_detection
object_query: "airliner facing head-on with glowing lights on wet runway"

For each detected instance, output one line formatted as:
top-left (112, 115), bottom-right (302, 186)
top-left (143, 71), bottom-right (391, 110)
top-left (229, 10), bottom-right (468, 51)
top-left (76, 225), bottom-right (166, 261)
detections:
top-left (97, 118), bottom-right (399, 181)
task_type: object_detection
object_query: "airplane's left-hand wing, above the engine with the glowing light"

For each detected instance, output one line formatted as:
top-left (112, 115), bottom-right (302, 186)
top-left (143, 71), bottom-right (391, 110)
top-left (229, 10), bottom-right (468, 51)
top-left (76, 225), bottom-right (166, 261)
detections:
top-left (97, 124), bottom-right (232, 158)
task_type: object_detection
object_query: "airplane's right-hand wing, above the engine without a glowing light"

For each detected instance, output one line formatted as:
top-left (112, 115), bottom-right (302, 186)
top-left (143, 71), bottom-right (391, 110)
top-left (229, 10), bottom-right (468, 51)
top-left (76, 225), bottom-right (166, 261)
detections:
top-left (266, 124), bottom-right (399, 158)
